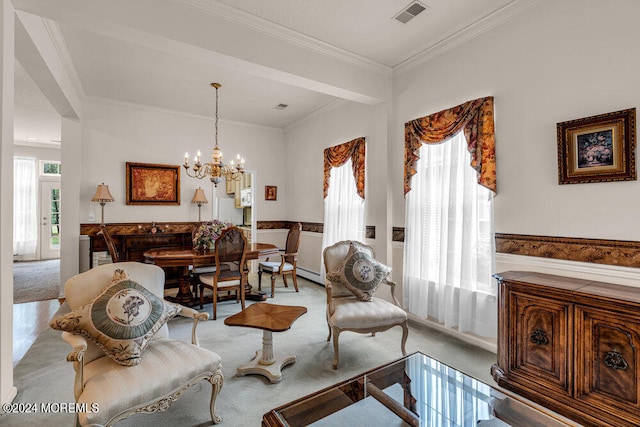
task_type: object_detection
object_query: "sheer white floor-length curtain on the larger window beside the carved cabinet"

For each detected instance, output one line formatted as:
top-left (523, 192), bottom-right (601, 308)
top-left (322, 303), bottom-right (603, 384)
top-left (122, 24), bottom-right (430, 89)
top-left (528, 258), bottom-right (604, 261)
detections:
top-left (402, 132), bottom-right (497, 337)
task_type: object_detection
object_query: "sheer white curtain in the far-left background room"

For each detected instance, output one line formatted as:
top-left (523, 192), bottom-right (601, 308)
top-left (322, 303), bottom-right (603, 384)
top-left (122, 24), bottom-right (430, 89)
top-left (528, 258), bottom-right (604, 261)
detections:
top-left (13, 157), bottom-right (38, 255)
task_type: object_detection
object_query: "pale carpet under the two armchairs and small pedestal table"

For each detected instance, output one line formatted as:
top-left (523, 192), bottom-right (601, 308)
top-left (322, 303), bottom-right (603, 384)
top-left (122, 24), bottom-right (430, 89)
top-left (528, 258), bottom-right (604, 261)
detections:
top-left (0, 278), bottom-right (496, 427)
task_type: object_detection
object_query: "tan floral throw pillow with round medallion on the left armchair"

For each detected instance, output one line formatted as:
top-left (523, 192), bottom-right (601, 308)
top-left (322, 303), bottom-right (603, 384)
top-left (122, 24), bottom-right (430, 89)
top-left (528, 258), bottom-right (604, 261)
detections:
top-left (49, 270), bottom-right (181, 366)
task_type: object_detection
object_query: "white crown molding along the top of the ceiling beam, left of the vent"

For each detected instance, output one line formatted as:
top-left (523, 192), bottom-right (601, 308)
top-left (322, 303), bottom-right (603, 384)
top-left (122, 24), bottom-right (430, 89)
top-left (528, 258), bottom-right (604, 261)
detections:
top-left (181, 0), bottom-right (393, 77)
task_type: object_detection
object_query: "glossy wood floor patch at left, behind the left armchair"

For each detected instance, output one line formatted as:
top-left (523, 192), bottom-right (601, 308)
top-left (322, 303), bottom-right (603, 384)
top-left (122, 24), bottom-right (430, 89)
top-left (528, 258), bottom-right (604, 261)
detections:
top-left (13, 299), bottom-right (60, 366)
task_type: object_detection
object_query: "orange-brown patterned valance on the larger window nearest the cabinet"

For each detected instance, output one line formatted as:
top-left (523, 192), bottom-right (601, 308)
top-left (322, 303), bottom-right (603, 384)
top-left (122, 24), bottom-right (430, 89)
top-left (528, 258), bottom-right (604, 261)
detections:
top-left (404, 96), bottom-right (496, 195)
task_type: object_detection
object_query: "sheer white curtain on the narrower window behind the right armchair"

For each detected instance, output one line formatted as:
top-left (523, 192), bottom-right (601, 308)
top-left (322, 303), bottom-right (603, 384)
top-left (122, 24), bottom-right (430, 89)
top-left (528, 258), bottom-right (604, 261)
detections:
top-left (320, 159), bottom-right (364, 277)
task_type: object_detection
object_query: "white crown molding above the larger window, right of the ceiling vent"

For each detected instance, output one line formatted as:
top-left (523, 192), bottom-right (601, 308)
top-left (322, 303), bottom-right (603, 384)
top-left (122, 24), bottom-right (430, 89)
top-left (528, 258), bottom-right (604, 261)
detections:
top-left (393, 0), bottom-right (542, 76)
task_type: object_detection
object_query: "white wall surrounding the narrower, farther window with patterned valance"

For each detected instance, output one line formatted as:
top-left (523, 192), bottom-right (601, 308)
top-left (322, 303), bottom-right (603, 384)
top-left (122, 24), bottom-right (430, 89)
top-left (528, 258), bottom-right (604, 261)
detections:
top-left (284, 102), bottom-right (388, 273)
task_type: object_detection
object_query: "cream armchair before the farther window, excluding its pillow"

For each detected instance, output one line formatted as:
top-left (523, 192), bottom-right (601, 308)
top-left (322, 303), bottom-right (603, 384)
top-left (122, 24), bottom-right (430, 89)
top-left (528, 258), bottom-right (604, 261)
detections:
top-left (323, 240), bottom-right (409, 369)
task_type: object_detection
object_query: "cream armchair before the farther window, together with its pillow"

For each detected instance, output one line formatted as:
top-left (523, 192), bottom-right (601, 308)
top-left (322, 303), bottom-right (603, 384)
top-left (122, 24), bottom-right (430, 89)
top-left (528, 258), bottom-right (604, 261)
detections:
top-left (323, 240), bottom-right (409, 369)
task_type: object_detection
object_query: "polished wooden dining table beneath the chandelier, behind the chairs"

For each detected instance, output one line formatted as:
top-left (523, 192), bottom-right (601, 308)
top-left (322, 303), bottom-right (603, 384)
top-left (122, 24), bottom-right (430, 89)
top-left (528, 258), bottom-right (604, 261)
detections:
top-left (143, 242), bottom-right (279, 307)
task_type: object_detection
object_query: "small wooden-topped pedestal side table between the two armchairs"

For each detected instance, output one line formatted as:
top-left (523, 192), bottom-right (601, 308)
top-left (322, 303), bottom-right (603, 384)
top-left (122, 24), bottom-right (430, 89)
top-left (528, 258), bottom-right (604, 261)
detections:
top-left (224, 302), bottom-right (307, 383)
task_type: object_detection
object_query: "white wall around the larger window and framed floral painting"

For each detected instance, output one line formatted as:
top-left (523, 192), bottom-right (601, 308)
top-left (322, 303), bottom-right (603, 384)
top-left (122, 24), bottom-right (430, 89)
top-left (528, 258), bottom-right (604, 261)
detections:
top-left (390, 0), bottom-right (640, 240)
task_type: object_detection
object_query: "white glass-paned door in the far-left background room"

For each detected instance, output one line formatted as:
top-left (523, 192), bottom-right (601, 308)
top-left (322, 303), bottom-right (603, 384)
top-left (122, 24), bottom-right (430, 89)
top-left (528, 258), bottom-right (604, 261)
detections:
top-left (39, 181), bottom-right (62, 259)
